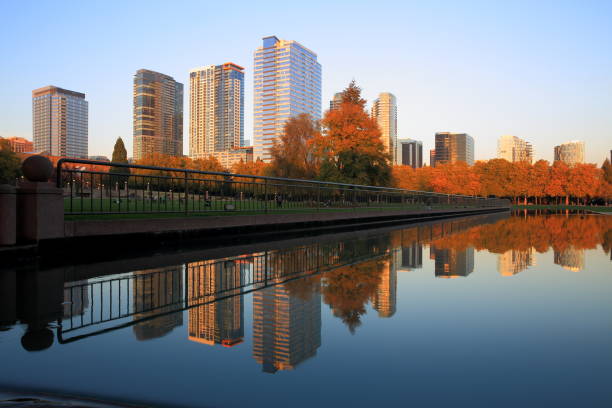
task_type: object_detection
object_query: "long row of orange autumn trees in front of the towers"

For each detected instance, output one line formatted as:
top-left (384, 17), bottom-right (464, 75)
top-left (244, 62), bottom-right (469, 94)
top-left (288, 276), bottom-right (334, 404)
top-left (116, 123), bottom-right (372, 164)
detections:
top-left (107, 81), bottom-right (612, 204)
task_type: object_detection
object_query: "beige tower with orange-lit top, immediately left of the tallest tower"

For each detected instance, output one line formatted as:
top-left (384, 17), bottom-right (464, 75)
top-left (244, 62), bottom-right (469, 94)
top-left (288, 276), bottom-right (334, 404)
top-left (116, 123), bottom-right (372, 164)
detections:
top-left (189, 62), bottom-right (244, 159)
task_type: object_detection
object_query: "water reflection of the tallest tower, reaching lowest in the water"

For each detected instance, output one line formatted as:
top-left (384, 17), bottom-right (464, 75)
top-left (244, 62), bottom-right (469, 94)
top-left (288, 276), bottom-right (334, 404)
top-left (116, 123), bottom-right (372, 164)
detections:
top-left (253, 284), bottom-right (321, 373)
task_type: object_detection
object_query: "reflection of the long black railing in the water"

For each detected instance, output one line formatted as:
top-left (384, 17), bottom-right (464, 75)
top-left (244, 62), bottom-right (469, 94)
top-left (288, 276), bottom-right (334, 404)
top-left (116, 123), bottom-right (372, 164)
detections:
top-left (58, 212), bottom-right (506, 342)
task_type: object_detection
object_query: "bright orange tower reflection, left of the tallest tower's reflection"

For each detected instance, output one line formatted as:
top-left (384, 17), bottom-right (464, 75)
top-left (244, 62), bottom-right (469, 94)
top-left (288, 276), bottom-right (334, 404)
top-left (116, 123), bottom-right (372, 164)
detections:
top-left (187, 260), bottom-right (244, 347)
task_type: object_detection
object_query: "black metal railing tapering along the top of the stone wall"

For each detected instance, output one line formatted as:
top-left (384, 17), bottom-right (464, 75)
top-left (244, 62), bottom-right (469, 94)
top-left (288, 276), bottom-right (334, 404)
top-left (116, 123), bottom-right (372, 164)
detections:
top-left (56, 158), bottom-right (510, 215)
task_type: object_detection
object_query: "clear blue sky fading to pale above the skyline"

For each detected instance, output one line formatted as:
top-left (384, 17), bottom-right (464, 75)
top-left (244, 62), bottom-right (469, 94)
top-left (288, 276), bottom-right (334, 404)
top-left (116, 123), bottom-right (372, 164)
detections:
top-left (0, 0), bottom-right (612, 163)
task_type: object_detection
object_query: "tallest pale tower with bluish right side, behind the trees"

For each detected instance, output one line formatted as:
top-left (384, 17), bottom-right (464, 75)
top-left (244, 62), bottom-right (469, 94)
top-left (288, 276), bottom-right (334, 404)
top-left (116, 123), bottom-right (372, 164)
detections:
top-left (253, 36), bottom-right (321, 161)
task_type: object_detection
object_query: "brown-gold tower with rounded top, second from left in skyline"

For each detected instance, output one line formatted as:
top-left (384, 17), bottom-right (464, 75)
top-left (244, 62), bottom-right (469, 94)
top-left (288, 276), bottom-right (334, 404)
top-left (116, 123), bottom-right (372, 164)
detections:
top-left (133, 69), bottom-right (183, 160)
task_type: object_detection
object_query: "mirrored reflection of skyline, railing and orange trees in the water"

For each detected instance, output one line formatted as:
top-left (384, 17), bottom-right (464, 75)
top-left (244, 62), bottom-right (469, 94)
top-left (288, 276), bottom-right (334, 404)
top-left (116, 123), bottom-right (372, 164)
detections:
top-left (14, 212), bottom-right (612, 362)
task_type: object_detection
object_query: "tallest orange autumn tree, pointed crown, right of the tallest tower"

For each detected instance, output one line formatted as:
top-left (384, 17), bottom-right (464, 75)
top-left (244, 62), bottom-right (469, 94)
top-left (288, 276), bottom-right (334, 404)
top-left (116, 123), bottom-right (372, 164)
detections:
top-left (310, 81), bottom-right (391, 186)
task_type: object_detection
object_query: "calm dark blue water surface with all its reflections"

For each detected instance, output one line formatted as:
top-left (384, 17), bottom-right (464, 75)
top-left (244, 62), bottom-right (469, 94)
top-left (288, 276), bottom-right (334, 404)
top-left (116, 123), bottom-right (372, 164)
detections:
top-left (0, 214), bottom-right (612, 407)
